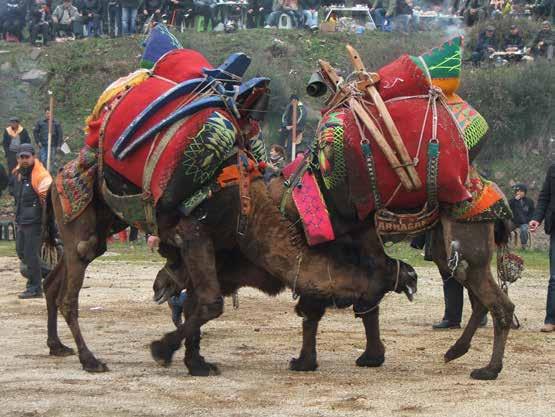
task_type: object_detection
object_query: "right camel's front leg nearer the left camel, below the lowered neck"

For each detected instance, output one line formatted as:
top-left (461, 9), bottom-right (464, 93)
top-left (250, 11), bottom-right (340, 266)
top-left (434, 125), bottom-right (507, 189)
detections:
top-left (289, 296), bottom-right (326, 371)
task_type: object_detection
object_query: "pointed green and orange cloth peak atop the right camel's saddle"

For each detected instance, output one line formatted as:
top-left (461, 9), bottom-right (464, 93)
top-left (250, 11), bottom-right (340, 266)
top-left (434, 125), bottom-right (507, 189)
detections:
top-left (411, 36), bottom-right (463, 100)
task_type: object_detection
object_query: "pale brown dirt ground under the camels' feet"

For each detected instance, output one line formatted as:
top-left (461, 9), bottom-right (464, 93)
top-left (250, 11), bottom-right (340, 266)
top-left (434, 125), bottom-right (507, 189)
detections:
top-left (0, 254), bottom-right (555, 417)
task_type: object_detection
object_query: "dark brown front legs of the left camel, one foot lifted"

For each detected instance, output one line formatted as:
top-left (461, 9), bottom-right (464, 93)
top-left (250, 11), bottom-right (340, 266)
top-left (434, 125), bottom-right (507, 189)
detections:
top-left (150, 219), bottom-right (223, 376)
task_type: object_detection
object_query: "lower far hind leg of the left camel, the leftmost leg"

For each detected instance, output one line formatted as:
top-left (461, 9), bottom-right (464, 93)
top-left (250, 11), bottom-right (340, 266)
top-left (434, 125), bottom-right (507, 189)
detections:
top-left (44, 260), bottom-right (75, 356)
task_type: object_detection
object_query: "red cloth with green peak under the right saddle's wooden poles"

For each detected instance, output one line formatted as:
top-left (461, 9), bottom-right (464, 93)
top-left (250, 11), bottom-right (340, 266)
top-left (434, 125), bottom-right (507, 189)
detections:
top-left (316, 38), bottom-right (487, 219)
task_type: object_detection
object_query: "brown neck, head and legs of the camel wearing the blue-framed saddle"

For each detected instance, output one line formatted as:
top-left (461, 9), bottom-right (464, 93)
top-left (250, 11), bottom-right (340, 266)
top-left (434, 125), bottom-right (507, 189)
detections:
top-left (44, 174), bottom-right (416, 376)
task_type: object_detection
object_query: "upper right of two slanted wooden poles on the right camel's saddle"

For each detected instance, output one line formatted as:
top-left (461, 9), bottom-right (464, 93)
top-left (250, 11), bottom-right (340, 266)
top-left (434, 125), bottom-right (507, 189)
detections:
top-left (347, 45), bottom-right (422, 191)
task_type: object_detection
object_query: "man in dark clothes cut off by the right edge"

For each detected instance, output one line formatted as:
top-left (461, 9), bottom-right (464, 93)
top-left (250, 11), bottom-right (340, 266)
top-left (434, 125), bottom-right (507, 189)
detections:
top-left (529, 163), bottom-right (555, 333)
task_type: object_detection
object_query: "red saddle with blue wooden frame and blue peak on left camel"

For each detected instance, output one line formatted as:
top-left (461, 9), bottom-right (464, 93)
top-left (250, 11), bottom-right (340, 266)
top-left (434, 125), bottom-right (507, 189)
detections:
top-left (57, 25), bottom-right (269, 232)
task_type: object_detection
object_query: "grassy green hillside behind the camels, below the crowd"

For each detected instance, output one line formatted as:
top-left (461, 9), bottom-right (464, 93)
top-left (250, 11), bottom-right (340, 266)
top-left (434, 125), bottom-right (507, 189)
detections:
top-left (0, 22), bottom-right (555, 195)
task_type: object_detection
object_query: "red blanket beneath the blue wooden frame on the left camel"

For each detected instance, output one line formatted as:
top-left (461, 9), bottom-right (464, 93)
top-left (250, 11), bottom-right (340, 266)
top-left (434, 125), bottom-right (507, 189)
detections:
top-left (85, 49), bottom-right (236, 202)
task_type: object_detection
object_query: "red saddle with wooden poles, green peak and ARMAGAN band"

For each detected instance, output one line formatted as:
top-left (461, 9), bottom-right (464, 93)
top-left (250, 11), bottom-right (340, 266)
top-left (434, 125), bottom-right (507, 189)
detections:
top-left (284, 37), bottom-right (510, 244)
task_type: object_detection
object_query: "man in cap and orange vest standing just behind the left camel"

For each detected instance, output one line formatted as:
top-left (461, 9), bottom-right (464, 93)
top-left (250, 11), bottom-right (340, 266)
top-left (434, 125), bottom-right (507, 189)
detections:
top-left (14, 143), bottom-right (52, 299)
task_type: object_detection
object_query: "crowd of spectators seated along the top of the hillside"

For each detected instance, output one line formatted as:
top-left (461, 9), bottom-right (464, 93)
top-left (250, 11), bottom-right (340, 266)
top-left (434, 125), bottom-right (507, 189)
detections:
top-left (0, 0), bottom-right (555, 45)
